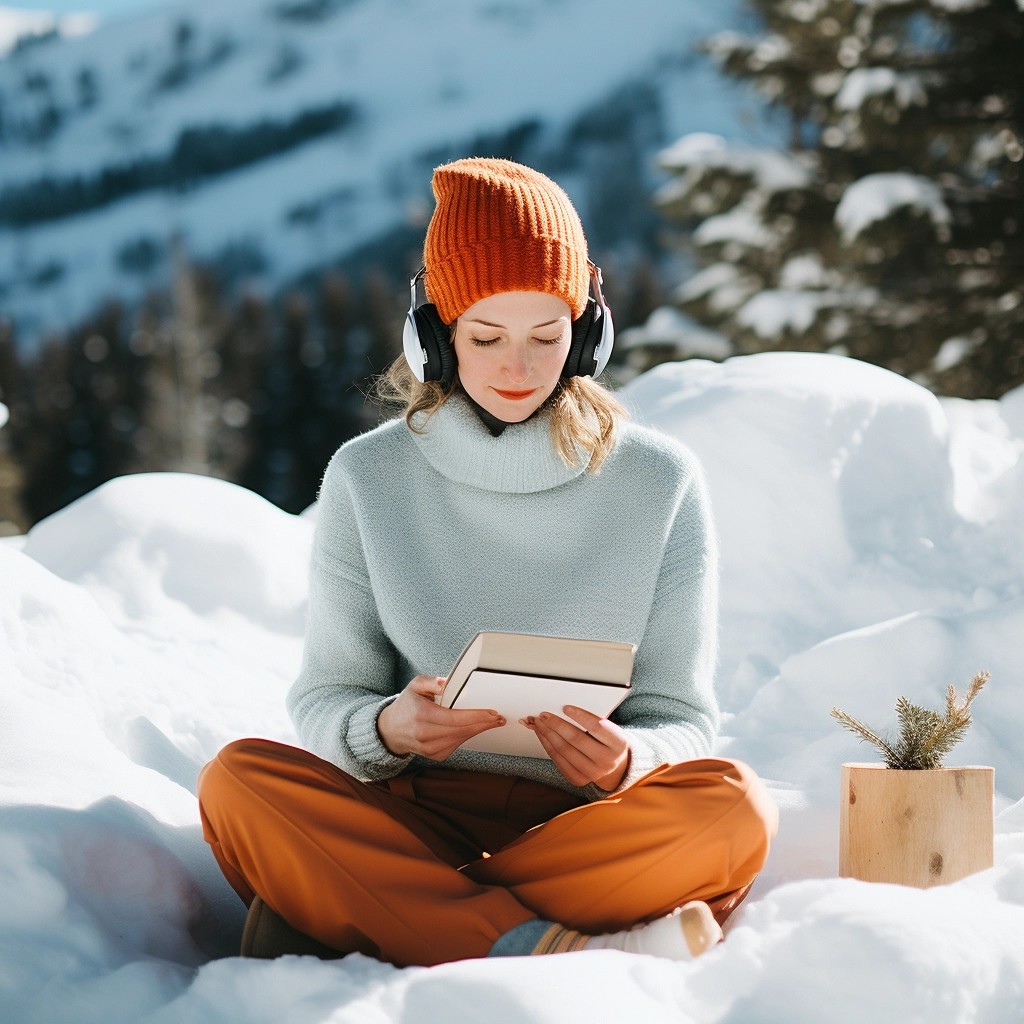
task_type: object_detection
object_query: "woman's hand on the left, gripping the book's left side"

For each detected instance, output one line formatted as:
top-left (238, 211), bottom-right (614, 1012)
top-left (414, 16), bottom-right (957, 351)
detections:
top-left (377, 676), bottom-right (505, 761)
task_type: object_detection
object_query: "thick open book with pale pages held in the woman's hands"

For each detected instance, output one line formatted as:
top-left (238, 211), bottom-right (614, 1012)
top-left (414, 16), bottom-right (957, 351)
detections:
top-left (437, 633), bottom-right (636, 758)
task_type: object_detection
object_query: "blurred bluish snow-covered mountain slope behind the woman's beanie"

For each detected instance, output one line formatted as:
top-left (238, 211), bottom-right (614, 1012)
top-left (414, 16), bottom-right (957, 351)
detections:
top-left (0, 0), bottom-right (743, 343)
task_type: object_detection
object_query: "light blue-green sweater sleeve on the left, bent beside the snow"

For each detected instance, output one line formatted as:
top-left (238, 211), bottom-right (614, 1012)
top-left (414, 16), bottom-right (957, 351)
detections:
top-left (287, 456), bottom-right (412, 779)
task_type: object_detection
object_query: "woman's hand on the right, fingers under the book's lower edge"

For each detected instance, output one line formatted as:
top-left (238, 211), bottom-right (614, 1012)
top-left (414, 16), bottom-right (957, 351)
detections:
top-left (522, 705), bottom-right (630, 791)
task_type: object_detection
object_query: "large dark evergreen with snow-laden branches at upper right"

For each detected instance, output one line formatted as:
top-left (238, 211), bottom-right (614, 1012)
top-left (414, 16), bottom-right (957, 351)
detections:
top-left (657, 0), bottom-right (1024, 397)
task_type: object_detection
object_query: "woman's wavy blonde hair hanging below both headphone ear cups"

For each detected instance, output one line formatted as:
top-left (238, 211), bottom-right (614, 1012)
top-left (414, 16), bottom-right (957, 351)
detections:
top-left (374, 356), bottom-right (630, 474)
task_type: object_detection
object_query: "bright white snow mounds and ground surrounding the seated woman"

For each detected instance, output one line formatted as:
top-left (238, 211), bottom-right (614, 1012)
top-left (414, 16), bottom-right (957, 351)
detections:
top-left (0, 352), bottom-right (1024, 1024)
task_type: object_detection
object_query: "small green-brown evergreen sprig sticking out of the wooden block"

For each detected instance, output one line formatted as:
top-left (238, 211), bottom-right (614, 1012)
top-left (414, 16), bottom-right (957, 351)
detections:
top-left (831, 672), bottom-right (988, 771)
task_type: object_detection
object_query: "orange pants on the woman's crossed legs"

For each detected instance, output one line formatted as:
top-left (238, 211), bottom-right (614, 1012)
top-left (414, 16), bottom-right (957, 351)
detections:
top-left (199, 739), bottom-right (778, 966)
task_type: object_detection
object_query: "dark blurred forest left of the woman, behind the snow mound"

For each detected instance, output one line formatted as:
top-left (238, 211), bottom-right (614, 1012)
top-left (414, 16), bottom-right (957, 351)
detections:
top-left (0, 254), bottom-right (403, 534)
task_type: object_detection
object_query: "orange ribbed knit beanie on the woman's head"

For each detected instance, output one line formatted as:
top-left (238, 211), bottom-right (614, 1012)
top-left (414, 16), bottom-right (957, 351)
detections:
top-left (423, 158), bottom-right (590, 324)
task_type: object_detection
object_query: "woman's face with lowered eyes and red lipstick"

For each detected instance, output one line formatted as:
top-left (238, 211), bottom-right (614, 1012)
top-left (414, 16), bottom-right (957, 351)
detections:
top-left (455, 292), bottom-right (572, 423)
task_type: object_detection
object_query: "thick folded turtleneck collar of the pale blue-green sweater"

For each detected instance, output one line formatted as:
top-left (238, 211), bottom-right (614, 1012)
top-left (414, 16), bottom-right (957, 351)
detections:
top-left (405, 392), bottom-right (589, 494)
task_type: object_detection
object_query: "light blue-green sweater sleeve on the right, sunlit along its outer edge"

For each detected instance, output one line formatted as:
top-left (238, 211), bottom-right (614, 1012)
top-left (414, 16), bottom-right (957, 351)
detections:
top-left (589, 460), bottom-right (719, 797)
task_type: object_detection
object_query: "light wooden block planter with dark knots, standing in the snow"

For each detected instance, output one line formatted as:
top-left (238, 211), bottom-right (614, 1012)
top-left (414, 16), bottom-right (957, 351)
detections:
top-left (839, 764), bottom-right (995, 889)
